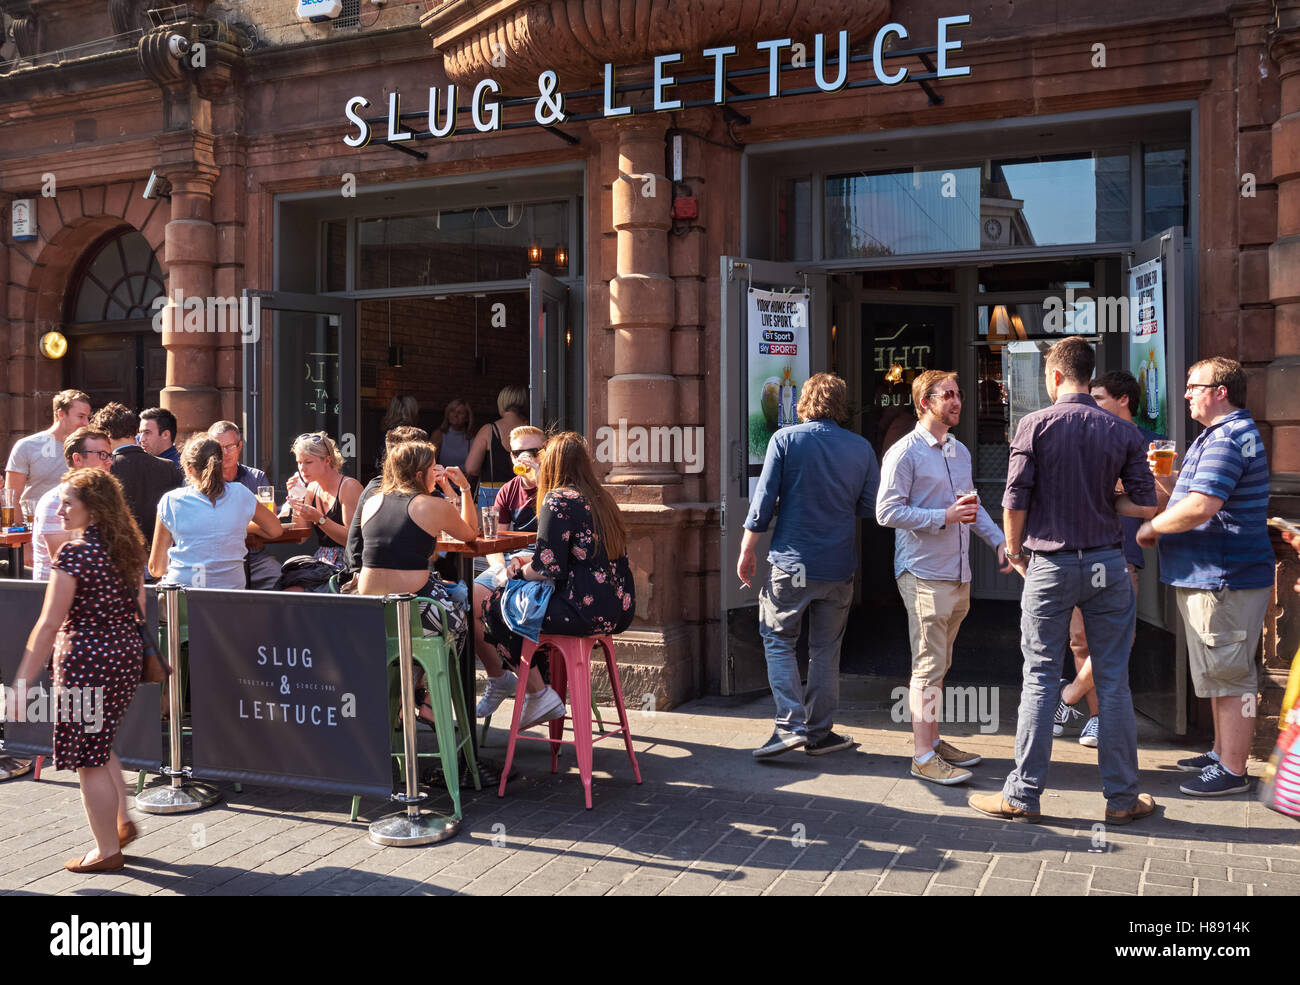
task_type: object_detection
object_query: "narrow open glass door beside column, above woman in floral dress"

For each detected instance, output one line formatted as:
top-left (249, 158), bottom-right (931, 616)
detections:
top-left (528, 270), bottom-right (585, 431)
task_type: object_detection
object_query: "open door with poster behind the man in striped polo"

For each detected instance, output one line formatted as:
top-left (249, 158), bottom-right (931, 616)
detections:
top-left (1125, 226), bottom-right (1188, 736)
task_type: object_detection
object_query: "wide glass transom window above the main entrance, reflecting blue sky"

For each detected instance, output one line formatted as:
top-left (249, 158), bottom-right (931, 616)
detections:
top-left (824, 149), bottom-right (1132, 260)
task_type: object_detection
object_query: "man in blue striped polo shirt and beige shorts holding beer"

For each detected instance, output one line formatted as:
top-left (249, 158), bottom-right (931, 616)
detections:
top-left (1138, 356), bottom-right (1274, 797)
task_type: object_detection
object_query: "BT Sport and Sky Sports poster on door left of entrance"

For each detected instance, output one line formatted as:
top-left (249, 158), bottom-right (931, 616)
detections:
top-left (746, 287), bottom-right (809, 467)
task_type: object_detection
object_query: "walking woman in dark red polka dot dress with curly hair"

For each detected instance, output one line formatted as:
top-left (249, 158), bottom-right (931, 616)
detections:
top-left (17, 469), bottom-right (146, 872)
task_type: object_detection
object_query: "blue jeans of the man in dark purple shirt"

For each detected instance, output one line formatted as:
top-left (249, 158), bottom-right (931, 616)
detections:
top-left (1002, 547), bottom-right (1138, 811)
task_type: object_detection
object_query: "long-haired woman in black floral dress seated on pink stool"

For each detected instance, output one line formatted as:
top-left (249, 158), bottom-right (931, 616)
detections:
top-left (481, 431), bottom-right (636, 729)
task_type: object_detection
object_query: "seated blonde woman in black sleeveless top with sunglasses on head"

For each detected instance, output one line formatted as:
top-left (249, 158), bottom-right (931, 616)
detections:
top-left (277, 431), bottom-right (361, 591)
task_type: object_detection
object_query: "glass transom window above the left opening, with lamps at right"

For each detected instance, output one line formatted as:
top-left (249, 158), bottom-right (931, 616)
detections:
top-left (356, 200), bottom-right (581, 290)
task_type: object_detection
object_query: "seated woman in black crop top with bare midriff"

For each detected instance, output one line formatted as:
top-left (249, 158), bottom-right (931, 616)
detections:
top-left (356, 441), bottom-right (478, 716)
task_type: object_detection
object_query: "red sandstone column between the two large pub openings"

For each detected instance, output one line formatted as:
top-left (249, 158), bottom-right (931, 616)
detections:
top-left (606, 114), bottom-right (681, 486)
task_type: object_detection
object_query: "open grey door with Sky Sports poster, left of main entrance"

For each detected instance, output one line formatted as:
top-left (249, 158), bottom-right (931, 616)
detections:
top-left (719, 256), bottom-right (831, 694)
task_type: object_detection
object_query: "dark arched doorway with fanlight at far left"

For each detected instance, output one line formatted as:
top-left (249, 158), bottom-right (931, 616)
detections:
top-left (64, 229), bottom-right (166, 411)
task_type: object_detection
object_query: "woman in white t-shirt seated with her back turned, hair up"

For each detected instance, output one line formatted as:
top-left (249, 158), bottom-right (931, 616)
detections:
top-left (150, 435), bottom-right (283, 589)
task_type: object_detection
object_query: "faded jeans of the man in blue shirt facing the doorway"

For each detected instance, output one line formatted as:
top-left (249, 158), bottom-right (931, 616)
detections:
top-left (758, 564), bottom-right (853, 742)
